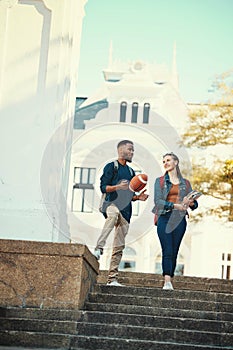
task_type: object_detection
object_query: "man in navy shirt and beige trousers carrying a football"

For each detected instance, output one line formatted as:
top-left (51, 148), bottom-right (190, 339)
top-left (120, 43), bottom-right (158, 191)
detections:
top-left (94, 140), bottom-right (148, 286)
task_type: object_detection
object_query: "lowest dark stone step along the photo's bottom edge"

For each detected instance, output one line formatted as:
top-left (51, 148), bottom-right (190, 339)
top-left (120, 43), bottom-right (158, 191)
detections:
top-left (0, 331), bottom-right (233, 350)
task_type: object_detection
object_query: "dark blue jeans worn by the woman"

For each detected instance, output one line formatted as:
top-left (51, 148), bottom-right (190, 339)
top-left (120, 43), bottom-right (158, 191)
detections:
top-left (157, 210), bottom-right (187, 277)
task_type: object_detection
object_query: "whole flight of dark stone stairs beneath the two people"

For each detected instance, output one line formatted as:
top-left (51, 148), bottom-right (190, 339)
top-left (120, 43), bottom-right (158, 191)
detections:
top-left (0, 271), bottom-right (233, 350)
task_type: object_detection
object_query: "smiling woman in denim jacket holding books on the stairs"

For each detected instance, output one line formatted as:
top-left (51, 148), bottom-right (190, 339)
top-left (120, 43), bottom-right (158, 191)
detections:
top-left (154, 152), bottom-right (198, 290)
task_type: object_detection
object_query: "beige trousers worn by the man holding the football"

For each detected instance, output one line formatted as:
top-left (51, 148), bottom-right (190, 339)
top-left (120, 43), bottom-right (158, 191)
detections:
top-left (95, 204), bottom-right (129, 282)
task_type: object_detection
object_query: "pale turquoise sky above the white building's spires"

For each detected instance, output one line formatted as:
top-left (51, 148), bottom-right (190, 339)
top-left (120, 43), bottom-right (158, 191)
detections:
top-left (77, 0), bottom-right (233, 103)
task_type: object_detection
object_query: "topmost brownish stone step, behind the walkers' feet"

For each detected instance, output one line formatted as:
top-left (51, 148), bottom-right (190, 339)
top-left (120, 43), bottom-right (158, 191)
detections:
top-left (98, 270), bottom-right (233, 294)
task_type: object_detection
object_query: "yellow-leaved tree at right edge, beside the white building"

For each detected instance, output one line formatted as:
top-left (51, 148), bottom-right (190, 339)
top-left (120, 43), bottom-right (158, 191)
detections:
top-left (182, 71), bottom-right (233, 221)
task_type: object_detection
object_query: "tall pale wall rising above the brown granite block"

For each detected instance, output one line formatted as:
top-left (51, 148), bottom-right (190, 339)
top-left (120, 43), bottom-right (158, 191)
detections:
top-left (0, 0), bottom-right (86, 242)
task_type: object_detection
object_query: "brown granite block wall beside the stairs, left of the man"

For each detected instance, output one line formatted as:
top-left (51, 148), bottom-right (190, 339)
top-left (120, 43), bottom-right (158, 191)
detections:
top-left (0, 240), bottom-right (99, 309)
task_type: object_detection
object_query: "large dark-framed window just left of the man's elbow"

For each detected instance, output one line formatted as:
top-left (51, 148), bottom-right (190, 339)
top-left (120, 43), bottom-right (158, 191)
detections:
top-left (71, 167), bottom-right (96, 213)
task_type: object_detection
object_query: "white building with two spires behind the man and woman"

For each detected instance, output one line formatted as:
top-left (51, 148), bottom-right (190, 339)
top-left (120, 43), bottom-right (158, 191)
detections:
top-left (68, 46), bottom-right (233, 278)
